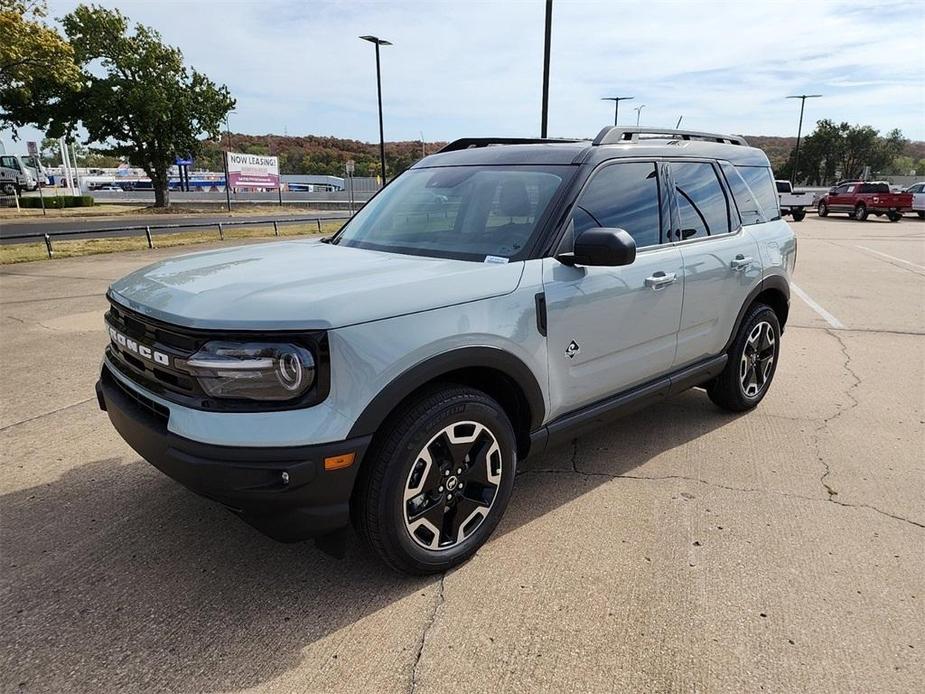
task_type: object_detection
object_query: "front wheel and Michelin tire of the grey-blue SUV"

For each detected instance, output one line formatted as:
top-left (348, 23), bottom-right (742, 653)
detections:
top-left (352, 384), bottom-right (517, 574)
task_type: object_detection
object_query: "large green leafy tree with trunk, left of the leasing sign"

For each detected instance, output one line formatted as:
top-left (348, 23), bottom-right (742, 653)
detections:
top-left (53, 5), bottom-right (235, 207)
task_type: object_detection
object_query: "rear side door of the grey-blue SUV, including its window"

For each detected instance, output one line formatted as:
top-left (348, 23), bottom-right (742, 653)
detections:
top-left (670, 161), bottom-right (760, 368)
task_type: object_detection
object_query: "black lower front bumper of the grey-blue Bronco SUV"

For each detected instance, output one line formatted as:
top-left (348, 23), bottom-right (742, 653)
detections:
top-left (96, 365), bottom-right (371, 542)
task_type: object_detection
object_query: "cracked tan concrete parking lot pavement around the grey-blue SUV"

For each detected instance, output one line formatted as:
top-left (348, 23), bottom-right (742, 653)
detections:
top-left (0, 215), bottom-right (925, 692)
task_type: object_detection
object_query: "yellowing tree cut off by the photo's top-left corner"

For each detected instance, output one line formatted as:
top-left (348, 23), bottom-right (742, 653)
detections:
top-left (0, 0), bottom-right (80, 139)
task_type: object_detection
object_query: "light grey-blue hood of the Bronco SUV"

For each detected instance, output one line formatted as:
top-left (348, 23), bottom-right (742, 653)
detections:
top-left (110, 240), bottom-right (523, 330)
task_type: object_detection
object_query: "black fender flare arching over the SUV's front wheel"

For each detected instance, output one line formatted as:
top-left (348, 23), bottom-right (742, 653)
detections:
top-left (347, 346), bottom-right (546, 438)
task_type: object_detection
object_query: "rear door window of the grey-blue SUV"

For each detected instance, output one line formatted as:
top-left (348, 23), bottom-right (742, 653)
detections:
top-left (671, 162), bottom-right (729, 241)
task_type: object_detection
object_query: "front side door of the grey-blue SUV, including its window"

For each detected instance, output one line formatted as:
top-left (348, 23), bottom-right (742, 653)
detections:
top-left (543, 161), bottom-right (682, 417)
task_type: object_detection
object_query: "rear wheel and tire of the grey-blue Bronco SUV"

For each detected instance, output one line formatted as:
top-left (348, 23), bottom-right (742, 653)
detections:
top-left (707, 303), bottom-right (780, 412)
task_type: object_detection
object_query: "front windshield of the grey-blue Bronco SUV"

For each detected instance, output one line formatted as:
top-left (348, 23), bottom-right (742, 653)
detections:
top-left (334, 166), bottom-right (571, 262)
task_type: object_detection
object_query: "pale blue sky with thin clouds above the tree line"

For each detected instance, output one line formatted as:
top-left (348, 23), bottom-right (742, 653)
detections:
top-left (0, 0), bottom-right (925, 151)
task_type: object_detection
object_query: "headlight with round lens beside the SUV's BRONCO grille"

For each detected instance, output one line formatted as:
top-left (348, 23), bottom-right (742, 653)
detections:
top-left (184, 341), bottom-right (315, 400)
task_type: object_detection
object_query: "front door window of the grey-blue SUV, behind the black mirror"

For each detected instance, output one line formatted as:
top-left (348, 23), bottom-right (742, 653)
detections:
top-left (568, 162), bottom-right (661, 248)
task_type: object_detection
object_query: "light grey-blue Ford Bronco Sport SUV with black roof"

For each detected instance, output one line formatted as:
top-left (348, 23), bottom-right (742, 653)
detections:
top-left (97, 128), bottom-right (796, 573)
